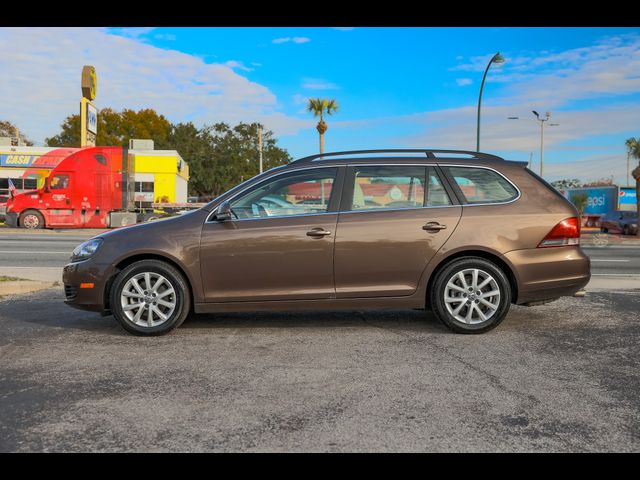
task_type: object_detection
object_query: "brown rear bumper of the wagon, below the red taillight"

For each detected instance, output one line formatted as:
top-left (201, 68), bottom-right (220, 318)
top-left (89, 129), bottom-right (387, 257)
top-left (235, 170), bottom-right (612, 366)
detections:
top-left (505, 246), bottom-right (591, 304)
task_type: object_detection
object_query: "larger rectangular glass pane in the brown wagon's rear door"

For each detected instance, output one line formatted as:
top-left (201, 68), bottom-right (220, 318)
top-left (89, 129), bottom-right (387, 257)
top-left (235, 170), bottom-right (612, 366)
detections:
top-left (351, 165), bottom-right (427, 210)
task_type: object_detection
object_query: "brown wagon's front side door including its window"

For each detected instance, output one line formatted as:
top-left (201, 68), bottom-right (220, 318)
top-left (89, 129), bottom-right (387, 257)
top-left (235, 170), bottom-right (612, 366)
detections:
top-left (200, 167), bottom-right (344, 302)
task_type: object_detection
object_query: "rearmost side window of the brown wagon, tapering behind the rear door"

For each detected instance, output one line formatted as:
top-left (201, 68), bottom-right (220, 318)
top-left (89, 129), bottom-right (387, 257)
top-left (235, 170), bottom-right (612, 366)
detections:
top-left (442, 167), bottom-right (518, 203)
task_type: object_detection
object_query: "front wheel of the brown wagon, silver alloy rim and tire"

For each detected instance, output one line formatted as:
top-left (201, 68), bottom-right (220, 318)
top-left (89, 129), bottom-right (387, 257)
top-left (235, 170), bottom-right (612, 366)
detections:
top-left (109, 260), bottom-right (191, 335)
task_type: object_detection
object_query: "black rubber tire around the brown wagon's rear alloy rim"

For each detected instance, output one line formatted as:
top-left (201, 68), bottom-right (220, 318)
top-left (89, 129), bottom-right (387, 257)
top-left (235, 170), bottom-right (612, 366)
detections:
top-left (429, 257), bottom-right (512, 333)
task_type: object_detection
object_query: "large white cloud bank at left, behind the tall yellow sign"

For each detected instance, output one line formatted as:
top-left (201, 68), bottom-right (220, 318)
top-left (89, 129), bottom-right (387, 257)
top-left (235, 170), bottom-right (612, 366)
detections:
top-left (0, 28), bottom-right (308, 142)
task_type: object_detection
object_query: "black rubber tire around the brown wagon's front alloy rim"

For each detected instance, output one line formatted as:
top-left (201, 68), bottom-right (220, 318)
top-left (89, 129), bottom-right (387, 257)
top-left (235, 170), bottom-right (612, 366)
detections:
top-left (109, 260), bottom-right (191, 336)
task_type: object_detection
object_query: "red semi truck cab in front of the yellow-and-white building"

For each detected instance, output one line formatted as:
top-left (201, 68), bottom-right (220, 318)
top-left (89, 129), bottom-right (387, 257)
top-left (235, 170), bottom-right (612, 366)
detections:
top-left (5, 147), bottom-right (136, 228)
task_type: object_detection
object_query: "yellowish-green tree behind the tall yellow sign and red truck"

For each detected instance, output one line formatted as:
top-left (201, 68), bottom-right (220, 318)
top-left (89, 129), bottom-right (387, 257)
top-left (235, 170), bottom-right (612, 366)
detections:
top-left (45, 108), bottom-right (171, 149)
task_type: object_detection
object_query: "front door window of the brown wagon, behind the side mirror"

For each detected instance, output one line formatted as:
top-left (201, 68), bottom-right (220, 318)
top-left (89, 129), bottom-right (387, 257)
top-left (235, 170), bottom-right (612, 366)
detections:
top-left (231, 168), bottom-right (338, 219)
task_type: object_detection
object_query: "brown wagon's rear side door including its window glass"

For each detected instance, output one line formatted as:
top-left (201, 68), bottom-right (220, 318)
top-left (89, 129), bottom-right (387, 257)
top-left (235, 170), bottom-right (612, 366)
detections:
top-left (334, 165), bottom-right (462, 298)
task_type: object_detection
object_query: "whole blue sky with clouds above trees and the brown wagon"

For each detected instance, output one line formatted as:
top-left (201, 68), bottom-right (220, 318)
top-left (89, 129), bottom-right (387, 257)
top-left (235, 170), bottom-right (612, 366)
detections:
top-left (0, 27), bottom-right (640, 183)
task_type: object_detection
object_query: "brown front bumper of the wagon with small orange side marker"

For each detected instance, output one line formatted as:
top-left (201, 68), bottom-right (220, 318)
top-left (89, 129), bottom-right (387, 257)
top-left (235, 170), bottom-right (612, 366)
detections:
top-left (62, 259), bottom-right (110, 313)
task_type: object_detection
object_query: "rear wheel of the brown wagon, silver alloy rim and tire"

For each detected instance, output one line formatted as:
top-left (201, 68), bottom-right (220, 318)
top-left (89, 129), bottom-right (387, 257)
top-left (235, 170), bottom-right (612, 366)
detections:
top-left (430, 257), bottom-right (511, 333)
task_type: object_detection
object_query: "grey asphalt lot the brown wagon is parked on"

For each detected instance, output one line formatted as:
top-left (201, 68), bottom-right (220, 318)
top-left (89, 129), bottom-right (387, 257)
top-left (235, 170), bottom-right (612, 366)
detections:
top-left (0, 288), bottom-right (640, 452)
